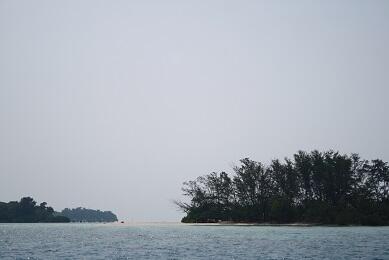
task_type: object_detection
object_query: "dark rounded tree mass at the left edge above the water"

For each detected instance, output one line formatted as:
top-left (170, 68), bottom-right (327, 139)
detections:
top-left (0, 197), bottom-right (70, 223)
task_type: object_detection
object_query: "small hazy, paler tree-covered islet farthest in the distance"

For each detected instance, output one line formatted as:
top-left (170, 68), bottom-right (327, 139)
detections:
top-left (59, 207), bottom-right (118, 222)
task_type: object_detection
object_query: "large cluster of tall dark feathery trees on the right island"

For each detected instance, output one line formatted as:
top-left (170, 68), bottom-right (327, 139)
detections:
top-left (176, 151), bottom-right (389, 225)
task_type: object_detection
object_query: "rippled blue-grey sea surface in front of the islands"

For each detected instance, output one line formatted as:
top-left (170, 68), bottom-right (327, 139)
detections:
top-left (0, 224), bottom-right (389, 259)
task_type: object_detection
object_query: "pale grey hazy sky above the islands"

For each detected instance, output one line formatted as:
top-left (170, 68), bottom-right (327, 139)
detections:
top-left (0, 0), bottom-right (389, 221)
